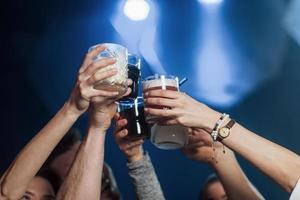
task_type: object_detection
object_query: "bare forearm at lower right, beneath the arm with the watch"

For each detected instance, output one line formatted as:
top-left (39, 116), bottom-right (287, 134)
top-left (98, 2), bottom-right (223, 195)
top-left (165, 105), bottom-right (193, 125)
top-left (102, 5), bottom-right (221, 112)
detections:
top-left (212, 149), bottom-right (264, 200)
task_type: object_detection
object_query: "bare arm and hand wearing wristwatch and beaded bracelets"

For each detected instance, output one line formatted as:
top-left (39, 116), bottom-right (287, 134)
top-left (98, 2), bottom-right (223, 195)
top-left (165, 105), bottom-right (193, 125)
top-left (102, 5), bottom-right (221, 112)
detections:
top-left (145, 91), bottom-right (300, 192)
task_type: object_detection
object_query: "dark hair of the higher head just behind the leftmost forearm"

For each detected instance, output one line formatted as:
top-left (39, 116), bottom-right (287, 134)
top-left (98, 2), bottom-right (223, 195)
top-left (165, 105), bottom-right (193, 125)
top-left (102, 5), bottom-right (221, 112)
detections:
top-left (44, 128), bottom-right (82, 167)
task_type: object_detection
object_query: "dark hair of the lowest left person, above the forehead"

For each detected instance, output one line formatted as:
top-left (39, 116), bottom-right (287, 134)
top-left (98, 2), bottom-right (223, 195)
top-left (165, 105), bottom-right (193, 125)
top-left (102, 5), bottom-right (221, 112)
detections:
top-left (36, 168), bottom-right (62, 194)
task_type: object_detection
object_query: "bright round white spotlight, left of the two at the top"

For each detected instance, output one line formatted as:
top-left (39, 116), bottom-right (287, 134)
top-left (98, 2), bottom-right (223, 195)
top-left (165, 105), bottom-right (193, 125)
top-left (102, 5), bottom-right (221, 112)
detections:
top-left (123, 0), bottom-right (150, 21)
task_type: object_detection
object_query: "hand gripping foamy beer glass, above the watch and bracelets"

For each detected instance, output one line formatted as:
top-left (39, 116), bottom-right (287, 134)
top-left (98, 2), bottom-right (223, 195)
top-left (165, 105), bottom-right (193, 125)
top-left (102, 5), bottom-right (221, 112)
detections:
top-left (144, 90), bottom-right (220, 132)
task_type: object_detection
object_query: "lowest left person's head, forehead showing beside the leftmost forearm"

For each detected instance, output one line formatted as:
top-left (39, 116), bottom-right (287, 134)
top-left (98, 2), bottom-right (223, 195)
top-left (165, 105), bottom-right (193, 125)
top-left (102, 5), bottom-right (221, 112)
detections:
top-left (22, 168), bottom-right (61, 200)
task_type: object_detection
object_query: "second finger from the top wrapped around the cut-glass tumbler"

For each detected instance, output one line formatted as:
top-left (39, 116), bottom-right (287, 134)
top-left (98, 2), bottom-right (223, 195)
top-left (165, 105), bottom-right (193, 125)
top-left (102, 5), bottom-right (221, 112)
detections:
top-left (79, 58), bottom-right (116, 81)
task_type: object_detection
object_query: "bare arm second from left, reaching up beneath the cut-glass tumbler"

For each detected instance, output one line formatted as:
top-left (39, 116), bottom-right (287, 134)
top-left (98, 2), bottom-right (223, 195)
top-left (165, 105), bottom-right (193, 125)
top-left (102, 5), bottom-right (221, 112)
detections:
top-left (57, 86), bottom-right (125, 200)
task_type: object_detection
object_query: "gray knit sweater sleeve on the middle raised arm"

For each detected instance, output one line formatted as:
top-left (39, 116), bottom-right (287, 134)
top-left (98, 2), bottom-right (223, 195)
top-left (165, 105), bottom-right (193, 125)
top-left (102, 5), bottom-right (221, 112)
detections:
top-left (127, 153), bottom-right (165, 200)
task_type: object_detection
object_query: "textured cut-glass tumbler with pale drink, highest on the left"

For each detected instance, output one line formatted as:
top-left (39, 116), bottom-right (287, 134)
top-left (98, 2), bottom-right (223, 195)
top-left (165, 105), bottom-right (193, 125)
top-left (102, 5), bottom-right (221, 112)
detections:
top-left (88, 43), bottom-right (128, 95)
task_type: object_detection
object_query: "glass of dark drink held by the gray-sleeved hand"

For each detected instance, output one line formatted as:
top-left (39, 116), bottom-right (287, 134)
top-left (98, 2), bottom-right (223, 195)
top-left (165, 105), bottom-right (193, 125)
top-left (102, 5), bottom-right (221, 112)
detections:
top-left (118, 97), bottom-right (150, 140)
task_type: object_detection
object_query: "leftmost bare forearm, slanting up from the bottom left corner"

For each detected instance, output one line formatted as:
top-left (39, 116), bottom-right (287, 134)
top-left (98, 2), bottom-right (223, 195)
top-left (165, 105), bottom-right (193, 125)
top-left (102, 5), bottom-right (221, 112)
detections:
top-left (0, 104), bottom-right (79, 199)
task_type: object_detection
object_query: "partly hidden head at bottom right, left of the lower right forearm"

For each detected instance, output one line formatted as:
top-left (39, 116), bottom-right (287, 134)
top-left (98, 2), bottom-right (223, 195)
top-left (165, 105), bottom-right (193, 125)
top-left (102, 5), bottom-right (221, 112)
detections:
top-left (199, 174), bottom-right (228, 200)
